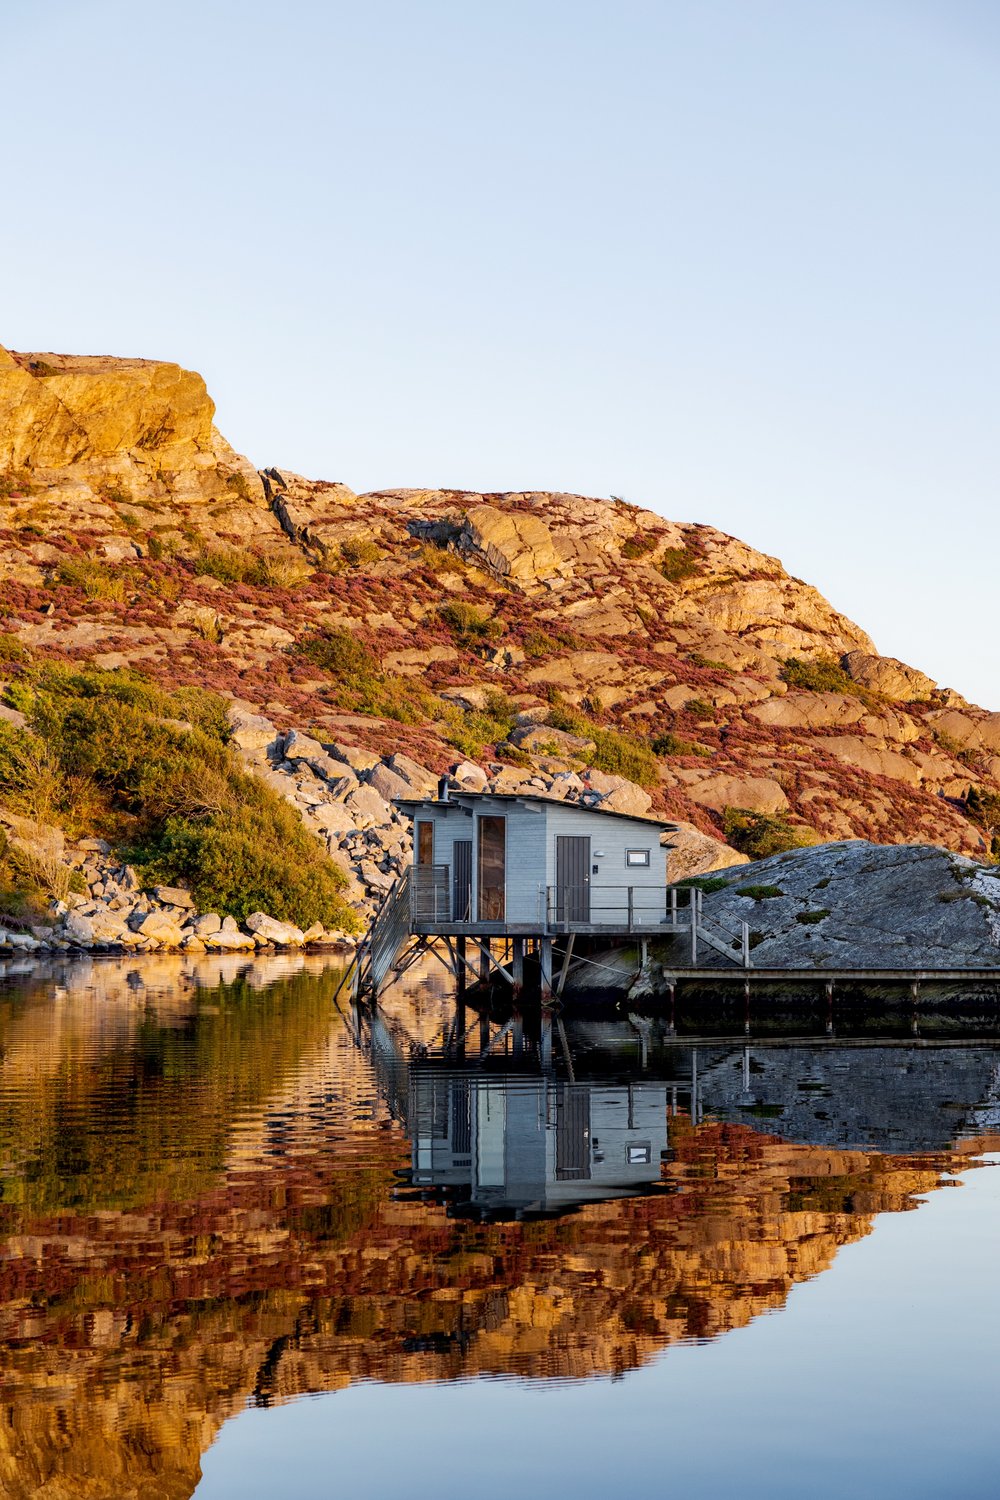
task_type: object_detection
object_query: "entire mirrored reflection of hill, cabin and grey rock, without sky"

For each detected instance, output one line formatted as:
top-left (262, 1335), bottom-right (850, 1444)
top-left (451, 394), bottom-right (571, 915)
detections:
top-left (0, 960), bottom-right (1000, 1500)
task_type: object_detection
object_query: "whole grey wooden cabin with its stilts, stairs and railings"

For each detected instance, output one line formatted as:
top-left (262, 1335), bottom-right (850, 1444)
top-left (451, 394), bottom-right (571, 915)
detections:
top-left (344, 777), bottom-right (749, 1007)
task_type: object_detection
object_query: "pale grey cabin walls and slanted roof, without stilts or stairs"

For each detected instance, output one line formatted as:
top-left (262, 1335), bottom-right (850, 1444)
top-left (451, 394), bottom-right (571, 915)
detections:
top-left (397, 783), bottom-right (676, 936)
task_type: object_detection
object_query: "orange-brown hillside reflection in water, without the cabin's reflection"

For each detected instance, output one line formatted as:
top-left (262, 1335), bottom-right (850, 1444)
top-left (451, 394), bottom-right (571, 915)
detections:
top-left (0, 977), bottom-right (995, 1500)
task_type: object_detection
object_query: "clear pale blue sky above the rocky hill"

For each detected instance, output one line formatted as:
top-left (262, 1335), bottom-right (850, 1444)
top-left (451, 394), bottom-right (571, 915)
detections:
top-left (0, 0), bottom-right (1000, 710)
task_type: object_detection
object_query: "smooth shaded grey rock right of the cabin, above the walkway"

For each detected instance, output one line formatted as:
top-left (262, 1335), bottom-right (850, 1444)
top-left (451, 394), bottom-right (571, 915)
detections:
top-left (664, 842), bottom-right (1000, 971)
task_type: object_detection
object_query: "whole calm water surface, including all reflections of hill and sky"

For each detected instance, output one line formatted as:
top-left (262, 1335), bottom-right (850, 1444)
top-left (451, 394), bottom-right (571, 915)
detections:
top-left (0, 957), bottom-right (1000, 1500)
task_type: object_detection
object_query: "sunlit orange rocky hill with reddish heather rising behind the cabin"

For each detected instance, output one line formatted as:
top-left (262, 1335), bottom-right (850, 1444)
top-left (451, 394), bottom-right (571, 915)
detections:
top-left (0, 350), bottom-right (1000, 942)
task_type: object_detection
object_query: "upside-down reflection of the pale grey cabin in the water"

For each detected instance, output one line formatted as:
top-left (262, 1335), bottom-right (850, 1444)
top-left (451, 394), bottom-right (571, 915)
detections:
top-left (408, 1070), bottom-right (669, 1218)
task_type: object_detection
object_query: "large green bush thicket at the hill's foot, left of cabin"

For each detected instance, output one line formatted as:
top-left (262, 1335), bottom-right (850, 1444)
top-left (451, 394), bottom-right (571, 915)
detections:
top-left (0, 666), bottom-right (357, 929)
